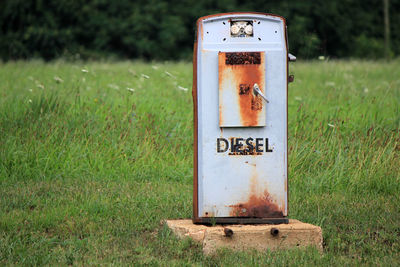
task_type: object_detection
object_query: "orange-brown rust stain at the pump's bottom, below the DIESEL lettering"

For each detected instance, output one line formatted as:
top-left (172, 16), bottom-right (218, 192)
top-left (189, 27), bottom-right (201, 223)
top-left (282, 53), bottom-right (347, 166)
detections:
top-left (229, 173), bottom-right (283, 218)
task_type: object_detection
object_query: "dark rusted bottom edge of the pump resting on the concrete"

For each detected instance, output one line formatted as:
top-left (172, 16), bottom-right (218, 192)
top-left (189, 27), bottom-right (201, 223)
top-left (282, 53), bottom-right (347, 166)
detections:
top-left (193, 217), bottom-right (289, 224)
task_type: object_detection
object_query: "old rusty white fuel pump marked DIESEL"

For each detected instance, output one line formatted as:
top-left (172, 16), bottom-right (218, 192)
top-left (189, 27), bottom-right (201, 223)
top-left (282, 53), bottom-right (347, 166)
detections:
top-left (193, 13), bottom-right (294, 224)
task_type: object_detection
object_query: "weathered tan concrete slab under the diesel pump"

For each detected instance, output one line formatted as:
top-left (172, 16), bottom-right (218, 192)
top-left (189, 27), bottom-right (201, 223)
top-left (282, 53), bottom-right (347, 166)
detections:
top-left (165, 219), bottom-right (322, 255)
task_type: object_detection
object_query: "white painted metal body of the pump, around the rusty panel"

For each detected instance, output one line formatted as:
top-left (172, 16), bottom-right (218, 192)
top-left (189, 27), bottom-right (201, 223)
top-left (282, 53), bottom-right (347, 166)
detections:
top-left (195, 13), bottom-right (288, 222)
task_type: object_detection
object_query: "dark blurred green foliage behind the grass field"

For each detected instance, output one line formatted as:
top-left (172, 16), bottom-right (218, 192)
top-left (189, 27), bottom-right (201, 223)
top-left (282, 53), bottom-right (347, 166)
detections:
top-left (0, 0), bottom-right (400, 60)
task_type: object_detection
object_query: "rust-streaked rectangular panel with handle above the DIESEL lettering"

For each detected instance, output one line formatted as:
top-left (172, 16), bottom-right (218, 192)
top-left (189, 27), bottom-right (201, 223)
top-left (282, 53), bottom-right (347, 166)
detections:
top-left (218, 52), bottom-right (265, 127)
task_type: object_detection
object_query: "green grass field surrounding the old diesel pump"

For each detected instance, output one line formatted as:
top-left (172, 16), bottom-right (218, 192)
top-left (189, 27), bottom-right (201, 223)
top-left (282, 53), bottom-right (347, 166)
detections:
top-left (0, 60), bottom-right (400, 266)
